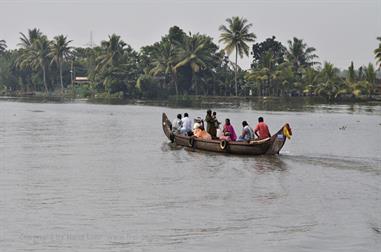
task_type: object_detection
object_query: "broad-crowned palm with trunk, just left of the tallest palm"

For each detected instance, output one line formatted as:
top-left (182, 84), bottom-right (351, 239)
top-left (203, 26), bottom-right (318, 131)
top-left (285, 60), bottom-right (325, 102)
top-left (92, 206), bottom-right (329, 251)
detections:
top-left (174, 34), bottom-right (217, 95)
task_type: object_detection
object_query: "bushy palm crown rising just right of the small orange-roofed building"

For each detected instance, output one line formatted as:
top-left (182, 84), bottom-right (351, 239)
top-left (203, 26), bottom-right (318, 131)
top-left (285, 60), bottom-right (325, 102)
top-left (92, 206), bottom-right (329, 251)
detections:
top-left (96, 34), bottom-right (127, 71)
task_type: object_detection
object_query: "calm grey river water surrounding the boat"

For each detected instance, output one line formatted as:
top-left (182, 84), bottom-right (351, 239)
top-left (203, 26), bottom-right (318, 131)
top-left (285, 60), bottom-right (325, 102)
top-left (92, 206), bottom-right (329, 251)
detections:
top-left (0, 99), bottom-right (381, 252)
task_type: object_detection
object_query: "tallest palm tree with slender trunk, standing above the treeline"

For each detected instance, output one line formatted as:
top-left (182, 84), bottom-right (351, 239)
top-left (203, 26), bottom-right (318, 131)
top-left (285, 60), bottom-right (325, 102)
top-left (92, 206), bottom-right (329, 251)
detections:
top-left (219, 17), bottom-right (256, 96)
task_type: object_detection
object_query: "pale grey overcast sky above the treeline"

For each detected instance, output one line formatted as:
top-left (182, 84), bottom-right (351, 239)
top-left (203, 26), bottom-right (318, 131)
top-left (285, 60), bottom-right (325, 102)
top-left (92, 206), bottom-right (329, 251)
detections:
top-left (0, 0), bottom-right (381, 68)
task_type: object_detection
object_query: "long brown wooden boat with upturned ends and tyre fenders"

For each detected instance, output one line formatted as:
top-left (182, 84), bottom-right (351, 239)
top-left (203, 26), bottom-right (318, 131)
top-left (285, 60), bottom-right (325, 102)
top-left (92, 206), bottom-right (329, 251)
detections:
top-left (162, 113), bottom-right (292, 155)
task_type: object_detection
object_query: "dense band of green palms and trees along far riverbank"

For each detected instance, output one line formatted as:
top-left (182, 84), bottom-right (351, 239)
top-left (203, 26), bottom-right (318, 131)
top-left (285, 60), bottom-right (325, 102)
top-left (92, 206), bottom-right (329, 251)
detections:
top-left (0, 17), bottom-right (381, 100)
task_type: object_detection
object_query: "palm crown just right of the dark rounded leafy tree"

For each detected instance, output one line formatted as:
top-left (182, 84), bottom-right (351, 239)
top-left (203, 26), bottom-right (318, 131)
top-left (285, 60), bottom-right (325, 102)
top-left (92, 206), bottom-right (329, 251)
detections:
top-left (287, 37), bottom-right (318, 72)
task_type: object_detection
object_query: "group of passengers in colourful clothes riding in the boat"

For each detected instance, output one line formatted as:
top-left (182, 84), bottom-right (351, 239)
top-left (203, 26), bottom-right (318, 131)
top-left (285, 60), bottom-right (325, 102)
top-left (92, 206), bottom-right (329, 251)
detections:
top-left (172, 109), bottom-right (271, 142)
